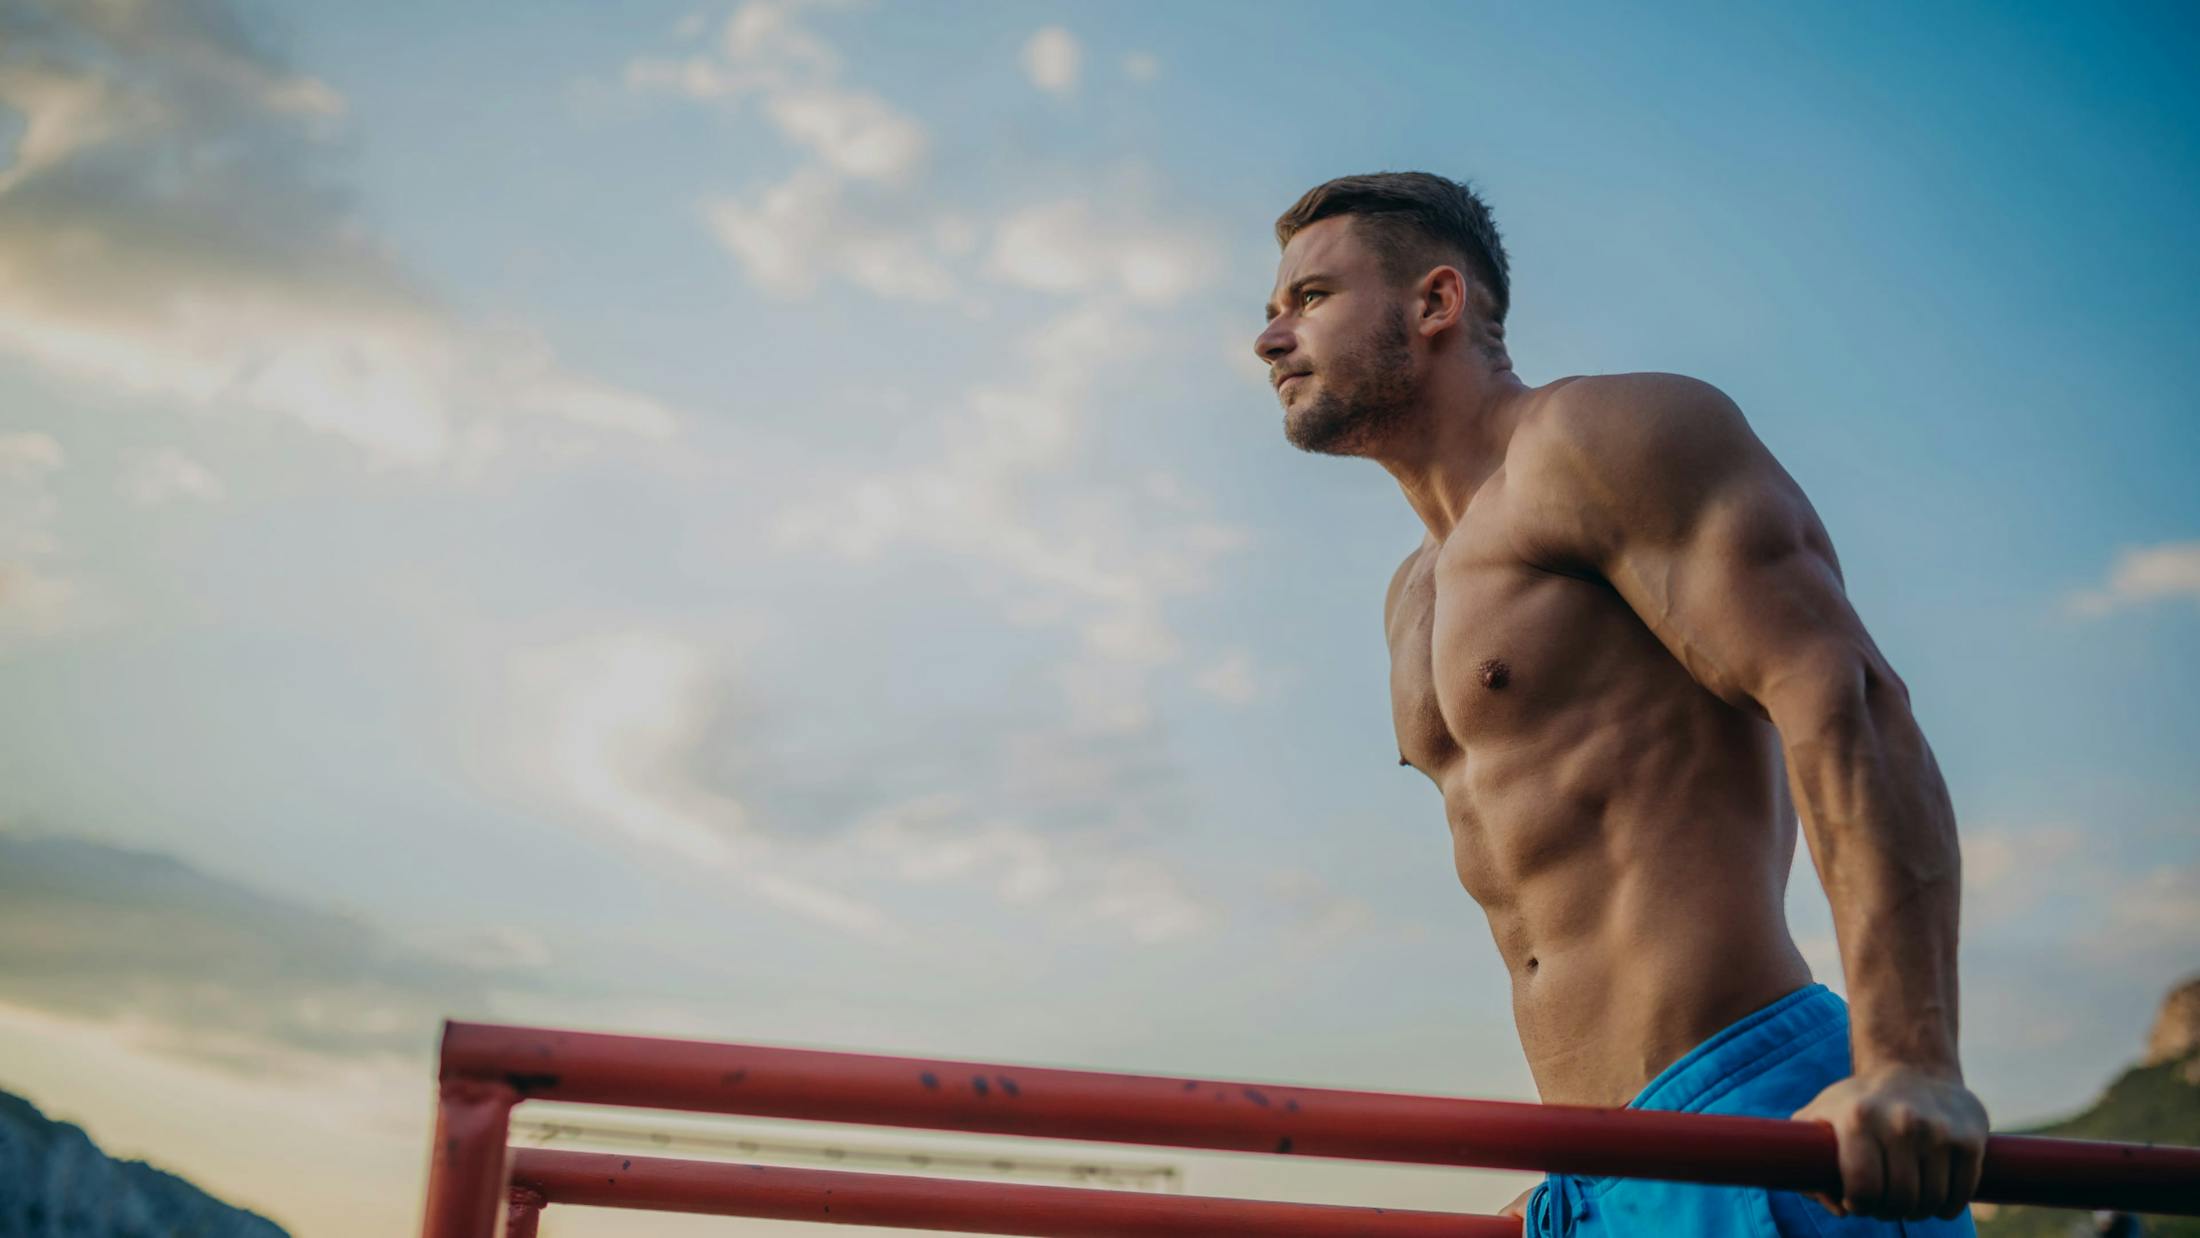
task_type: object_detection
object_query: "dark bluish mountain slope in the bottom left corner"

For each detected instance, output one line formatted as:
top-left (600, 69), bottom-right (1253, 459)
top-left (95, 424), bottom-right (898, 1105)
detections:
top-left (0, 1093), bottom-right (288, 1238)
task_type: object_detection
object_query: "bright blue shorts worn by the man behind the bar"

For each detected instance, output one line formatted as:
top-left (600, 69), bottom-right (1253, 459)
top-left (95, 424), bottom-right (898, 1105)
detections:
top-left (1525, 985), bottom-right (1976, 1238)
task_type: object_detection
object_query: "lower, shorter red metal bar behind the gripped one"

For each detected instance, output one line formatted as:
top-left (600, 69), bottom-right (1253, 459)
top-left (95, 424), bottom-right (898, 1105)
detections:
top-left (513, 1148), bottom-right (1520, 1238)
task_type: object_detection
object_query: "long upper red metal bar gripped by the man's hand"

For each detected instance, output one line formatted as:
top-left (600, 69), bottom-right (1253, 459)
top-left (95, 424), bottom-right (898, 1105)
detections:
top-left (436, 1023), bottom-right (2200, 1213)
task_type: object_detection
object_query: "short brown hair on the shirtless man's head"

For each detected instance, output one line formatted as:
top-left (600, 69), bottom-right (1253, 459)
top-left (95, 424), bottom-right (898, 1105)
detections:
top-left (1276, 172), bottom-right (1511, 323)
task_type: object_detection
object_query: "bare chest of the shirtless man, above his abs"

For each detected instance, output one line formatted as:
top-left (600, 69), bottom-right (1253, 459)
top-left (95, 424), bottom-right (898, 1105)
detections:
top-left (1388, 514), bottom-right (1637, 770)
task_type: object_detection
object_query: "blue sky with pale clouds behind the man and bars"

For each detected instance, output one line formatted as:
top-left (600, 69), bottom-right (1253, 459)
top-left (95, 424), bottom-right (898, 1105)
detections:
top-left (0, 0), bottom-right (2200, 1238)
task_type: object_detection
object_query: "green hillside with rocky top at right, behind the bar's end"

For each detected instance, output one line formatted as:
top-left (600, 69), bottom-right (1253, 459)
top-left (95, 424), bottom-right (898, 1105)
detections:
top-left (1973, 976), bottom-right (2200, 1238)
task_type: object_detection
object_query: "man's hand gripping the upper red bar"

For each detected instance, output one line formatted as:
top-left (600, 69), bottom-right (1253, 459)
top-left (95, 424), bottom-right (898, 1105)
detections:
top-left (1795, 1066), bottom-right (1987, 1220)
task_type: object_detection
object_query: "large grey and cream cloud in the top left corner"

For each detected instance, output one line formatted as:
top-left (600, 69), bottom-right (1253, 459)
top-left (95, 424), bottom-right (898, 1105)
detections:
top-left (0, 2), bottom-right (675, 468)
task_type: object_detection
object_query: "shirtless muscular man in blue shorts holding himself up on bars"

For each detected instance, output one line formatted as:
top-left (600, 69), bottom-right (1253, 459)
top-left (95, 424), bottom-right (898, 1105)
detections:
top-left (1254, 174), bottom-right (1987, 1236)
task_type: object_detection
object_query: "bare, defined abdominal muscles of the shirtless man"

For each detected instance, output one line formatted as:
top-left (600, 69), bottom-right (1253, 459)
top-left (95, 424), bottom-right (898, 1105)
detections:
top-left (1437, 695), bottom-right (1808, 1104)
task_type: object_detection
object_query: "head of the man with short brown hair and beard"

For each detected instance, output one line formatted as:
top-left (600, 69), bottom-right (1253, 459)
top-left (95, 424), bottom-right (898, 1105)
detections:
top-left (1254, 172), bottom-right (1511, 455)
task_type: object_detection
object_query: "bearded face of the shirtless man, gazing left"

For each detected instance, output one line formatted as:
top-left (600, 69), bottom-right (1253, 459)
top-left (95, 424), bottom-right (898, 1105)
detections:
top-left (1252, 215), bottom-right (1419, 455)
